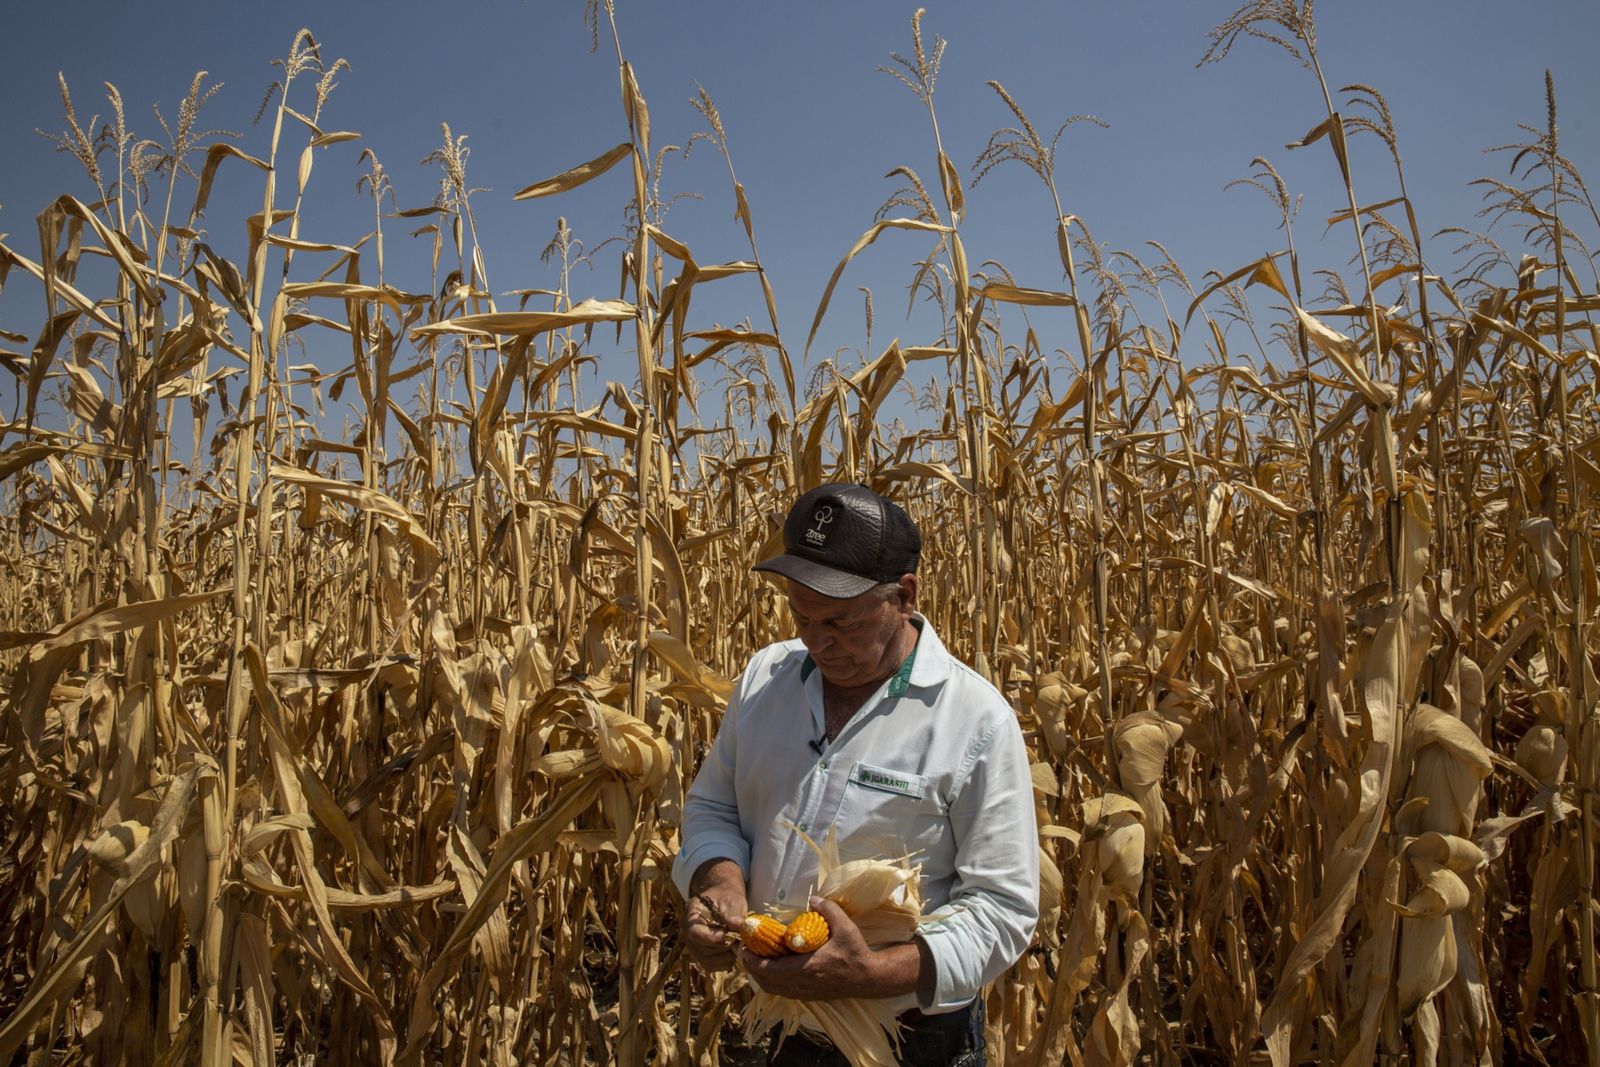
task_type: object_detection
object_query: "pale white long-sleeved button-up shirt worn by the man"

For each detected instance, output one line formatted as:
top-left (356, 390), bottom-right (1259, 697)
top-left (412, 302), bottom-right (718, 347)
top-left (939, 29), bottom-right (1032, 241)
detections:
top-left (672, 616), bottom-right (1038, 1013)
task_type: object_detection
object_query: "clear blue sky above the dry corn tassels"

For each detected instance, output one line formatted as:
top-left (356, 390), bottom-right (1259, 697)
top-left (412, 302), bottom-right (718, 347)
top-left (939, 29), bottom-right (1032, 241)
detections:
top-left (0, 0), bottom-right (1600, 408)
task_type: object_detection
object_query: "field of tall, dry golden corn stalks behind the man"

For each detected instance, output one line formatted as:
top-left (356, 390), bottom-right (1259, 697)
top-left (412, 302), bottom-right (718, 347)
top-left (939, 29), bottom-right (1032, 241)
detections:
top-left (0, 0), bottom-right (1600, 1067)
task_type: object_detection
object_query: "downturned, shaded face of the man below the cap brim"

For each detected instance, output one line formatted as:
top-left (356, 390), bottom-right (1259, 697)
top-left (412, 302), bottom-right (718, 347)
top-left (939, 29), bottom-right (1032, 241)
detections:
top-left (789, 574), bottom-right (917, 688)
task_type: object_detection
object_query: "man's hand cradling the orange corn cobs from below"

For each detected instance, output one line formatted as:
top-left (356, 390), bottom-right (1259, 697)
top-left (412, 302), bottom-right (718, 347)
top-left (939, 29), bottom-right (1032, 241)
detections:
top-left (744, 896), bottom-right (933, 1000)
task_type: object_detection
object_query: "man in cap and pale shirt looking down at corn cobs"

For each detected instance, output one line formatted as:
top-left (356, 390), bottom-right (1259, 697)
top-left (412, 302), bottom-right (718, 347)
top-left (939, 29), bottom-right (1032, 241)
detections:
top-left (672, 485), bottom-right (1038, 1065)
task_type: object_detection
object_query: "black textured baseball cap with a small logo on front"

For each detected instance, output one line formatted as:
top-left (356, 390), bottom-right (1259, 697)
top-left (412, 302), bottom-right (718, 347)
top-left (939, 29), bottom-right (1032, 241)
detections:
top-left (752, 482), bottom-right (922, 600)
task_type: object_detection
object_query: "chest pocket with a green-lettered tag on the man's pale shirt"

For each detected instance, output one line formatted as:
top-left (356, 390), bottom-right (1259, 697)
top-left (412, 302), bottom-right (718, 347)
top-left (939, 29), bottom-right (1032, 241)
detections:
top-left (834, 761), bottom-right (955, 862)
